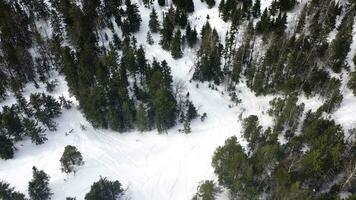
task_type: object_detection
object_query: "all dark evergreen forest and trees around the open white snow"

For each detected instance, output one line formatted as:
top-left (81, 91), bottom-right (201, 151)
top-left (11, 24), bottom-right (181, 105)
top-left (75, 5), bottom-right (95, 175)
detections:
top-left (0, 0), bottom-right (356, 200)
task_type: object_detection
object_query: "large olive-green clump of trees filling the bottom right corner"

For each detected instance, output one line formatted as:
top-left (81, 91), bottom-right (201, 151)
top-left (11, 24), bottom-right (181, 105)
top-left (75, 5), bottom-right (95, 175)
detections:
top-left (211, 111), bottom-right (356, 199)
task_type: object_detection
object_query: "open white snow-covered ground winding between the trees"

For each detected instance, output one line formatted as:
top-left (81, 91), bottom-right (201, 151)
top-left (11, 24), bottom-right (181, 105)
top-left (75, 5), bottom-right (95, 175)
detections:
top-left (0, 0), bottom-right (356, 200)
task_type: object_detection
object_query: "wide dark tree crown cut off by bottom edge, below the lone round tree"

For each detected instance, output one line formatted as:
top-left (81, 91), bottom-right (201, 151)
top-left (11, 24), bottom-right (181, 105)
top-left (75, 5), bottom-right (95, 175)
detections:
top-left (85, 177), bottom-right (124, 200)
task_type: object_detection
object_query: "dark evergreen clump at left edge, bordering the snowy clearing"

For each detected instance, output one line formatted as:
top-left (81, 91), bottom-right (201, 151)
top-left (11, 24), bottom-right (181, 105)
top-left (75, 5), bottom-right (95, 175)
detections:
top-left (0, 93), bottom-right (64, 159)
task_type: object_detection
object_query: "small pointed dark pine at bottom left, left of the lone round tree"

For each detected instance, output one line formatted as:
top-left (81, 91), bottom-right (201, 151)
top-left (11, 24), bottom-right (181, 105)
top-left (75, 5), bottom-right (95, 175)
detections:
top-left (28, 167), bottom-right (52, 200)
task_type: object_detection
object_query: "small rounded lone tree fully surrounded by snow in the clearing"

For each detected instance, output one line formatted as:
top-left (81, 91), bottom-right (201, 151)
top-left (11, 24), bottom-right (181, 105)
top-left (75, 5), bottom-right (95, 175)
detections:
top-left (59, 145), bottom-right (84, 174)
